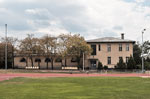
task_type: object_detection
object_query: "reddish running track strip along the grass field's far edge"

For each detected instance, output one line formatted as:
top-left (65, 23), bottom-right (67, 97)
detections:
top-left (0, 73), bottom-right (150, 81)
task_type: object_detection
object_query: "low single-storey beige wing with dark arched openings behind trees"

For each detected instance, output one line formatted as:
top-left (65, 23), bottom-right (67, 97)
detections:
top-left (14, 55), bottom-right (78, 70)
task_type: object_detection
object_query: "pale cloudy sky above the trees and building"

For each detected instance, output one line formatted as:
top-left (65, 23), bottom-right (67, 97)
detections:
top-left (0, 0), bottom-right (150, 41)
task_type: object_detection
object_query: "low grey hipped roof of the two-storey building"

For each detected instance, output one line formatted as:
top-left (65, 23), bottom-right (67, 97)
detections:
top-left (86, 37), bottom-right (135, 43)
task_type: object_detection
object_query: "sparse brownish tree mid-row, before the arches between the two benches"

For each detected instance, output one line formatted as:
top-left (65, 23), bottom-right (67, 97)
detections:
top-left (40, 35), bottom-right (57, 70)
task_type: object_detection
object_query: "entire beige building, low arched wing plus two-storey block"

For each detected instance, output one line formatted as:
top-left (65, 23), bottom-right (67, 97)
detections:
top-left (14, 34), bottom-right (135, 69)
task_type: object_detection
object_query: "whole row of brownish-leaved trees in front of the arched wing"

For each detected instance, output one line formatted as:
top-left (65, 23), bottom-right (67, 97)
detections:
top-left (4, 34), bottom-right (92, 69)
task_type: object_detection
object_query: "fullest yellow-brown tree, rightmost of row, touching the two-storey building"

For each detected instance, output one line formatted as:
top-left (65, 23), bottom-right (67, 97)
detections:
top-left (67, 34), bottom-right (92, 68)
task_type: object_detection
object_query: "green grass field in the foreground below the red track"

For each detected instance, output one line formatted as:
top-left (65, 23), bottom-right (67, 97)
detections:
top-left (0, 77), bottom-right (150, 99)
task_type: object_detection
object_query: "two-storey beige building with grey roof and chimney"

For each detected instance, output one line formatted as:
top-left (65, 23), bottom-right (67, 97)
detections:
top-left (86, 34), bottom-right (135, 68)
